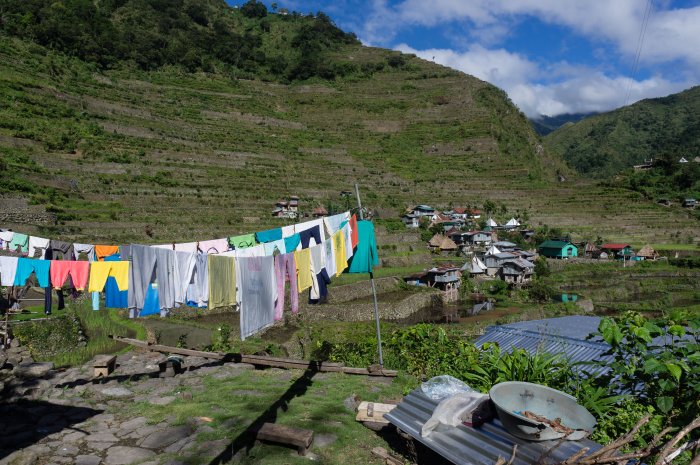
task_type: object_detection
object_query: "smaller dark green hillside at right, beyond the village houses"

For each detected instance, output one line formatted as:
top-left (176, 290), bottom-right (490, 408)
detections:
top-left (545, 87), bottom-right (700, 178)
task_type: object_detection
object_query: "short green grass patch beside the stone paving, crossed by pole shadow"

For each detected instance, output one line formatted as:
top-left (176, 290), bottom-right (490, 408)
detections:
top-left (119, 369), bottom-right (403, 465)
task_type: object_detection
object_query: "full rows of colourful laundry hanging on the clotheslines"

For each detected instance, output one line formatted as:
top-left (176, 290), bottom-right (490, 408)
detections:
top-left (0, 213), bottom-right (378, 338)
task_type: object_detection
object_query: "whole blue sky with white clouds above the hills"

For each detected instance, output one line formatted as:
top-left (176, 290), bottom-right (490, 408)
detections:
top-left (237, 0), bottom-right (700, 118)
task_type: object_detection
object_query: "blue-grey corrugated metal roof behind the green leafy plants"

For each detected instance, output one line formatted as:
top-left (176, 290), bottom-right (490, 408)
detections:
top-left (475, 316), bottom-right (612, 374)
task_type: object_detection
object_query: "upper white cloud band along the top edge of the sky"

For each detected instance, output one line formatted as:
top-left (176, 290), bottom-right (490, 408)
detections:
top-left (362, 0), bottom-right (700, 70)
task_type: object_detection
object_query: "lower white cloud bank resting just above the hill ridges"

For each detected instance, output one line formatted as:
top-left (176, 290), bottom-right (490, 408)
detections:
top-left (396, 44), bottom-right (691, 117)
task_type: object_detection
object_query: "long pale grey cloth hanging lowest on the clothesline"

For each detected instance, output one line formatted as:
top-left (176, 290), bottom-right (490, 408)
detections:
top-left (236, 257), bottom-right (277, 340)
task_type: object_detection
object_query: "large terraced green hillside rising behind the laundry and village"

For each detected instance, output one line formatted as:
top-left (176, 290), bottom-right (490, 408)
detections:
top-left (0, 0), bottom-right (698, 243)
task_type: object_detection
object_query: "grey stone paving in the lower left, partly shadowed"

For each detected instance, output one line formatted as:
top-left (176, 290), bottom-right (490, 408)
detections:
top-left (0, 352), bottom-right (264, 465)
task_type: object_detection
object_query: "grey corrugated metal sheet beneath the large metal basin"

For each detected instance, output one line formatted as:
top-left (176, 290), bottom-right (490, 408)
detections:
top-left (384, 388), bottom-right (600, 465)
